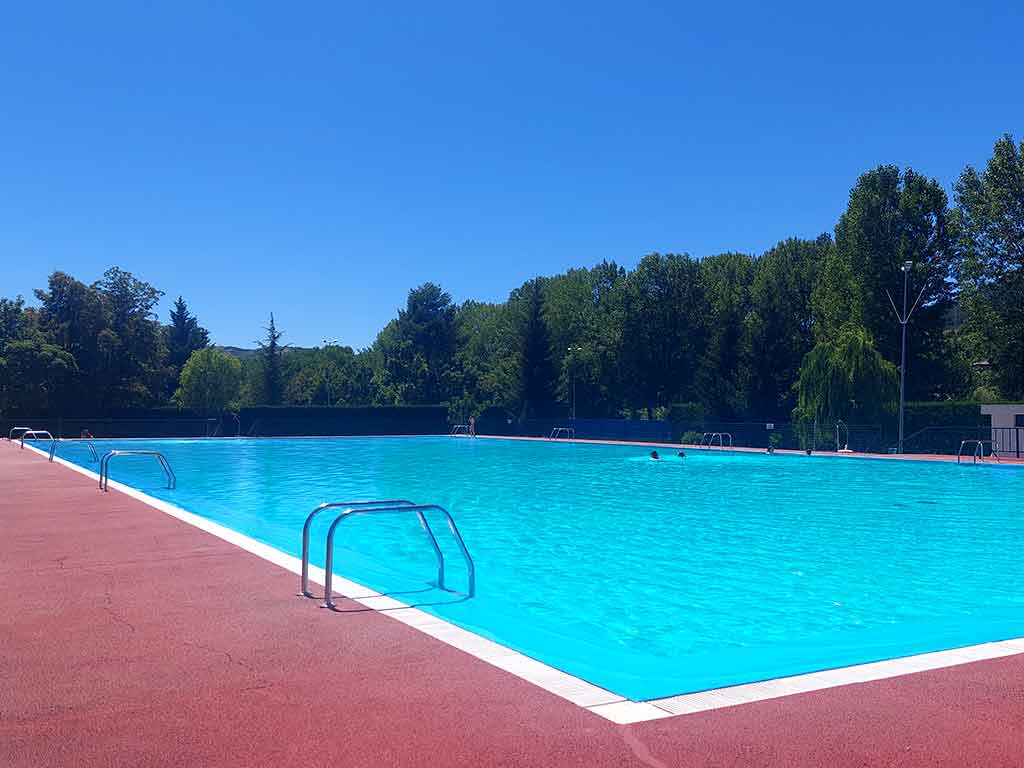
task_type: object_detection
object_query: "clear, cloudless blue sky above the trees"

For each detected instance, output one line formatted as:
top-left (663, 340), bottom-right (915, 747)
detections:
top-left (0, 0), bottom-right (1024, 347)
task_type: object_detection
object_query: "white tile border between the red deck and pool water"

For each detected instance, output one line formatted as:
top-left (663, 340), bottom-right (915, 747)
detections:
top-left (10, 442), bottom-right (1024, 725)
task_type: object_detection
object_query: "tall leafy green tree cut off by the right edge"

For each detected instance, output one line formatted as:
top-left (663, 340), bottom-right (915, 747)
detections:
top-left (955, 134), bottom-right (1024, 398)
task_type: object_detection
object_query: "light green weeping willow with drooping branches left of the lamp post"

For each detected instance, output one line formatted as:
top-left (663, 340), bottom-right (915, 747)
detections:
top-left (794, 326), bottom-right (899, 434)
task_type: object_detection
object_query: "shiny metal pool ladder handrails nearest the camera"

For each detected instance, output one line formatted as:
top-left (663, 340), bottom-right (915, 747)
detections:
top-left (299, 499), bottom-right (476, 608)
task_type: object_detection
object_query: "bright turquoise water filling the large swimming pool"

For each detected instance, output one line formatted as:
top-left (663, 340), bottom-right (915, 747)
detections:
top-left (51, 437), bottom-right (1024, 699)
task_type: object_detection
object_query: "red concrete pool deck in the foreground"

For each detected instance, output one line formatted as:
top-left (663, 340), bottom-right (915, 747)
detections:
top-left (0, 442), bottom-right (1024, 768)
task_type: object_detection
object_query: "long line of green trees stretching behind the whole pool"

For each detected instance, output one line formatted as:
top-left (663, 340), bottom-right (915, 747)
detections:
top-left (0, 136), bottom-right (1024, 421)
